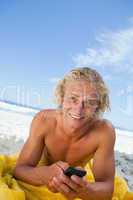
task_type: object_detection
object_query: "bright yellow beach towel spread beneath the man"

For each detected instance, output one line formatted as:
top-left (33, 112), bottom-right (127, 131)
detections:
top-left (0, 155), bottom-right (133, 200)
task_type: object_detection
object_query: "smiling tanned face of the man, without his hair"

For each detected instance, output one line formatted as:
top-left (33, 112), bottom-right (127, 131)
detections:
top-left (62, 80), bottom-right (99, 127)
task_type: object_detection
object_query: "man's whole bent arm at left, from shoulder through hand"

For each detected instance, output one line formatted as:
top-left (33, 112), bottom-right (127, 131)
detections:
top-left (14, 111), bottom-right (69, 192)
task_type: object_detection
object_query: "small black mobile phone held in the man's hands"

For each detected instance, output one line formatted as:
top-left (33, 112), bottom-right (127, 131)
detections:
top-left (64, 167), bottom-right (86, 177)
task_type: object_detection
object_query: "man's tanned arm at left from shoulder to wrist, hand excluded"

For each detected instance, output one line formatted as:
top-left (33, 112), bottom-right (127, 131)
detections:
top-left (14, 111), bottom-right (48, 185)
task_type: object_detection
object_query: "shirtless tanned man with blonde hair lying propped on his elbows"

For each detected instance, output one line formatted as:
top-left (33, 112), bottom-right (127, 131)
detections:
top-left (14, 67), bottom-right (115, 200)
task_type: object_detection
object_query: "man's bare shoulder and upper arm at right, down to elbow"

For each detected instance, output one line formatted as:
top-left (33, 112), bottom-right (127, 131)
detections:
top-left (92, 119), bottom-right (115, 187)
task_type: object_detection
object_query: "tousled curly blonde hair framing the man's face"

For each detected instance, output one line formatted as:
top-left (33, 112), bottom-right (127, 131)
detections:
top-left (55, 67), bottom-right (110, 116)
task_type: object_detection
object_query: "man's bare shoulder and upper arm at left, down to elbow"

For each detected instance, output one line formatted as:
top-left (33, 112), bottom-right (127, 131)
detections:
top-left (14, 110), bottom-right (55, 166)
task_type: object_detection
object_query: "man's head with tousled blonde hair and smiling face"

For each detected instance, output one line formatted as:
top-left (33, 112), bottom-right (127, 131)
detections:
top-left (56, 67), bottom-right (109, 122)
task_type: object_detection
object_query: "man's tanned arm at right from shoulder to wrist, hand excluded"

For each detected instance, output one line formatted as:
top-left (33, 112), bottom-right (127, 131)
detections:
top-left (75, 122), bottom-right (115, 200)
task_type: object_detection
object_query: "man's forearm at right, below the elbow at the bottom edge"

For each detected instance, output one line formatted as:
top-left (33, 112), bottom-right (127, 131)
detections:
top-left (82, 182), bottom-right (113, 200)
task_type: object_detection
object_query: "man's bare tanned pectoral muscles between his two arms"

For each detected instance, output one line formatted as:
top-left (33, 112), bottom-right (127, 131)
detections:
top-left (44, 133), bottom-right (97, 166)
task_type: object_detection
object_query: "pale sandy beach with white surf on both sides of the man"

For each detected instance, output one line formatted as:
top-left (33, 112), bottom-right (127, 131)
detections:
top-left (0, 102), bottom-right (133, 191)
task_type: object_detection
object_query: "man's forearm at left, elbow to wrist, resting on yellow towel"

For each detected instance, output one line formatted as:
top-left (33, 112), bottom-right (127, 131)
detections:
top-left (13, 166), bottom-right (49, 186)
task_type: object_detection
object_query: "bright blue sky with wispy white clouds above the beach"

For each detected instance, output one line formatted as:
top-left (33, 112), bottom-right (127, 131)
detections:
top-left (0, 0), bottom-right (133, 130)
